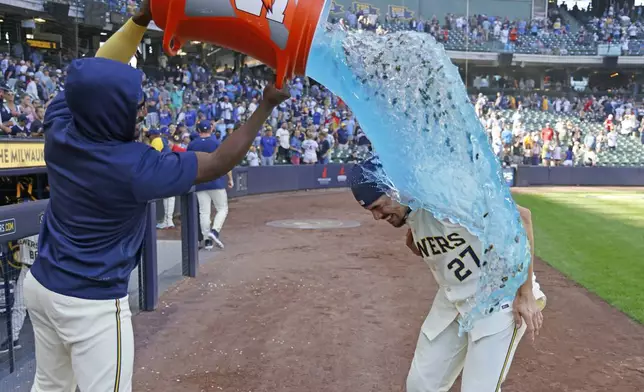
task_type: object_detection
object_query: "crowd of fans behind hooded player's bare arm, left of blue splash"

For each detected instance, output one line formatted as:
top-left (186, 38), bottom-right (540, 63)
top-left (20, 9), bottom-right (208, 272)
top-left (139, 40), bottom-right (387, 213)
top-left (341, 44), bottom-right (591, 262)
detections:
top-left (143, 65), bottom-right (370, 166)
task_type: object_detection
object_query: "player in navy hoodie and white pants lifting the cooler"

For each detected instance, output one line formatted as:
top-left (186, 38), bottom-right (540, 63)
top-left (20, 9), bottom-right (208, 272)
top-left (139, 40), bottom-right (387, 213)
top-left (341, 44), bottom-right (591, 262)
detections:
top-left (24, 0), bottom-right (288, 392)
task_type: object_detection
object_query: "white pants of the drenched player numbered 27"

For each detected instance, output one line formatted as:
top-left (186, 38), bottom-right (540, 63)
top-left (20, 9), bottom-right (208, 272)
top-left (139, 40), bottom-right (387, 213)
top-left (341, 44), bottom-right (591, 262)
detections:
top-left (407, 320), bottom-right (526, 392)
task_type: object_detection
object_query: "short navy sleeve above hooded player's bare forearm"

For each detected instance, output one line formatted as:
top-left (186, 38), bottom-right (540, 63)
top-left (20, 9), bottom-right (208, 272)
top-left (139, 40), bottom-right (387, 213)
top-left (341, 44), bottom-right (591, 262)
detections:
top-left (132, 148), bottom-right (197, 202)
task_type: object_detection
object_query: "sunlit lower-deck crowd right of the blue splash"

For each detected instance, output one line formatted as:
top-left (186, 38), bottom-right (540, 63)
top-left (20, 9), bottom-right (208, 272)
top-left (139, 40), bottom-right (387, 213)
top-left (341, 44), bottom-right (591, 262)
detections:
top-left (473, 93), bottom-right (644, 166)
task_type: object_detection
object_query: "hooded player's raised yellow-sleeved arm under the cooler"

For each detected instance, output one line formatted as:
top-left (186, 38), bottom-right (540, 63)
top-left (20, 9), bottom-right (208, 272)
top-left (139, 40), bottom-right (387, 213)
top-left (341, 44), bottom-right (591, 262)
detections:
top-left (96, 0), bottom-right (152, 64)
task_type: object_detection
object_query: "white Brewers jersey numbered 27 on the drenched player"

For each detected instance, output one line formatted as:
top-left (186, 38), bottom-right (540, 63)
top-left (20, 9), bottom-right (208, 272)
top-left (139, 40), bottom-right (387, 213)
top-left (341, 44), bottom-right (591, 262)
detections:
top-left (407, 209), bottom-right (544, 340)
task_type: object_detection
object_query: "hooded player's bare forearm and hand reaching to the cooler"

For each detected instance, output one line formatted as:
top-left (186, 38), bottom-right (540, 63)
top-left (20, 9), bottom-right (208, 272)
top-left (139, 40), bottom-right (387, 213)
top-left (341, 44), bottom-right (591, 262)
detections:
top-left (195, 86), bottom-right (289, 184)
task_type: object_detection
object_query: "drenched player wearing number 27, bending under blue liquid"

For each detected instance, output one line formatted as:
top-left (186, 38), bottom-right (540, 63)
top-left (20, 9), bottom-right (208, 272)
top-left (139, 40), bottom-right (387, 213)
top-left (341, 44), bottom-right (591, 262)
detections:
top-left (351, 161), bottom-right (546, 392)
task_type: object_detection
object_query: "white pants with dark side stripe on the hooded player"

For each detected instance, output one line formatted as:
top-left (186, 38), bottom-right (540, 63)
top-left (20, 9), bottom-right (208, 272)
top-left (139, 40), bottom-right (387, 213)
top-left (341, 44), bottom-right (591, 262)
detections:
top-left (24, 273), bottom-right (134, 392)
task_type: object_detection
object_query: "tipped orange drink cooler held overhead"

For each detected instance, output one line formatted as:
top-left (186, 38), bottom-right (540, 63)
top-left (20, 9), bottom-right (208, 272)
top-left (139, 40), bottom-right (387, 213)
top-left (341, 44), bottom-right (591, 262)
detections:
top-left (150, 0), bottom-right (331, 88)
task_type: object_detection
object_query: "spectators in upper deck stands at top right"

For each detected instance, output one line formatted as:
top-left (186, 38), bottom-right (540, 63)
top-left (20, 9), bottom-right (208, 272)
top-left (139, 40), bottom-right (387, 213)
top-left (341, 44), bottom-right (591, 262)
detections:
top-left (338, 2), bottom-right (644, 55)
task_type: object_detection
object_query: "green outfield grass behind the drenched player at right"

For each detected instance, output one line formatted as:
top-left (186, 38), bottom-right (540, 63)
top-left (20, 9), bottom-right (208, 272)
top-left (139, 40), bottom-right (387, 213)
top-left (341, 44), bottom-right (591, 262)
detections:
top-left (514, 191), bottom-right (644, 322)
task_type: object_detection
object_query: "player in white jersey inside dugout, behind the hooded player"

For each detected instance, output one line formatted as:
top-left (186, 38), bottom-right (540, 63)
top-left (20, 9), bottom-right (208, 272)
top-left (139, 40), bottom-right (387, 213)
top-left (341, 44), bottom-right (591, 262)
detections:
top-left (0, 235), bottom-right (38, 353)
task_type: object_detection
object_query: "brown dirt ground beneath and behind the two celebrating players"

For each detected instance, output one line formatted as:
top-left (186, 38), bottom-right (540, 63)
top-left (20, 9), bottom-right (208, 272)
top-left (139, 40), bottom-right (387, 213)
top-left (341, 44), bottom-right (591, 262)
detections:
top-left (134, 191), bottom-right (644, 392)
